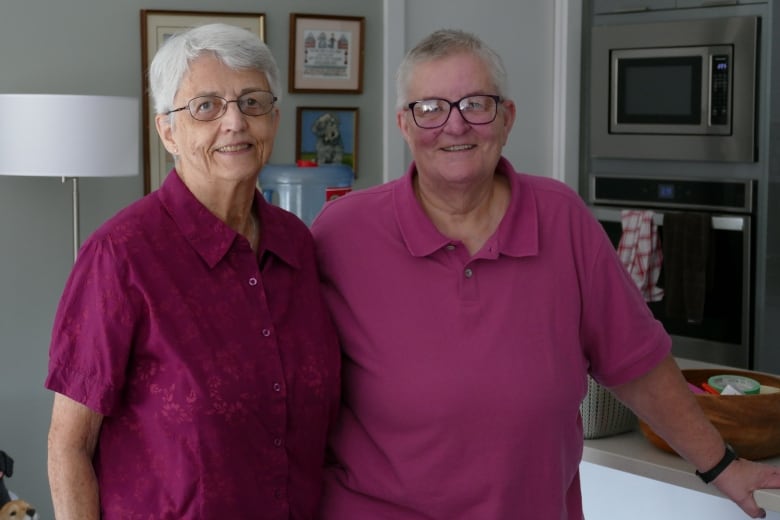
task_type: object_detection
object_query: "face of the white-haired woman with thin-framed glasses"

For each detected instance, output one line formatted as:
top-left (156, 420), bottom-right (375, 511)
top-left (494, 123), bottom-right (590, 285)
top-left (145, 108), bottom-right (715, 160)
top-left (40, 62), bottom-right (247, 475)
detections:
top-left (156, 54), bottom-right (279, 188)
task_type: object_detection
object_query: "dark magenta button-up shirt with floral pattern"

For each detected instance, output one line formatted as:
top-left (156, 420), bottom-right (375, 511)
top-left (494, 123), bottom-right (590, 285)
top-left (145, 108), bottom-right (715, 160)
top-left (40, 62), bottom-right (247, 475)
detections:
top-left (46, 171), bottom-right (340, 520)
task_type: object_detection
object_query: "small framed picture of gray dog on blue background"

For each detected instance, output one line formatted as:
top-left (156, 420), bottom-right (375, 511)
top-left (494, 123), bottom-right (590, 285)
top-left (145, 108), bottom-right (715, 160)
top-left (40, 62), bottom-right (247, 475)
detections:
top-left (295, 107), bottom-right (358, 178)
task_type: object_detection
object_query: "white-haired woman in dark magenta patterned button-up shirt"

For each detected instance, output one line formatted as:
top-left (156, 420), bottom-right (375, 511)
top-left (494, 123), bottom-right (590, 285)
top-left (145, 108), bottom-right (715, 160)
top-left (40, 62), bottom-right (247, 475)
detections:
top-left (46, 24), bottom-right (339, 520)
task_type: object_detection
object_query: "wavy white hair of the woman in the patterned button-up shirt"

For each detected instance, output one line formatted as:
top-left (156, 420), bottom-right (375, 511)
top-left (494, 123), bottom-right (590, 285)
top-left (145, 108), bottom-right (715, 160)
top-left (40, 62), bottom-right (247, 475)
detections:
top-left (149, 23), bottom-right (282, 114)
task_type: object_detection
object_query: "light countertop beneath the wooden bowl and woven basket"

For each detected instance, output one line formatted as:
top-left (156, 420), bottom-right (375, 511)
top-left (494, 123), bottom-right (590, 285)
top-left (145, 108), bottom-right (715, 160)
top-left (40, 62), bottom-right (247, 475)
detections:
top-left (582, 359), bottom-right (780, 512)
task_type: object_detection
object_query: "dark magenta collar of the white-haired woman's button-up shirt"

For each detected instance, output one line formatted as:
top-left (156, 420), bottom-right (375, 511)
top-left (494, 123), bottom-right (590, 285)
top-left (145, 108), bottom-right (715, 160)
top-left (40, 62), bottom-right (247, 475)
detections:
top-left (159, 169), bottom-right (299, 268)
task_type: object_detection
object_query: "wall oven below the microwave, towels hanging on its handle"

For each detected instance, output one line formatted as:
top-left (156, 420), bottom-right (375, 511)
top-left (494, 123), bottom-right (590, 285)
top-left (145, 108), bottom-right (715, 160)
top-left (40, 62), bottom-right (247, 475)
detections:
top-left (589, 175), bottom-right (756, 368)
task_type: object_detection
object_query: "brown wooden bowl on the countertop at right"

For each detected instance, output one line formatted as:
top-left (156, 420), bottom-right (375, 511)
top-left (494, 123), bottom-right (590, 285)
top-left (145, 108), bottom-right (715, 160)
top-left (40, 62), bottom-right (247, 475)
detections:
top-left (639, 369), bottom-right (780, 460)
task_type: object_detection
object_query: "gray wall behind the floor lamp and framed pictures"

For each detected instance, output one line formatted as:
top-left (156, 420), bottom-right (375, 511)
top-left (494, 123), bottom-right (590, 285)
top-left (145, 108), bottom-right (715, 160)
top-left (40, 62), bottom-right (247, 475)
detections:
top-left (0, 0), bottom-right (383, 519)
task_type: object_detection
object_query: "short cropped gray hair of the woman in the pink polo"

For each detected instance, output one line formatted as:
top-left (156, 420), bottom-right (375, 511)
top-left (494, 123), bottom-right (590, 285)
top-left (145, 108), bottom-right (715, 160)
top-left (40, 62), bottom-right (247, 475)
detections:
top-left (395, 29), bottom-right (509, 110)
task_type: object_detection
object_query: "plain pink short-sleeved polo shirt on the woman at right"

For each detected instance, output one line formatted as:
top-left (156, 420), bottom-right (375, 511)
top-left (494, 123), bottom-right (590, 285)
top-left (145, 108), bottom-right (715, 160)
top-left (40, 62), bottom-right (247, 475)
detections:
top-left (312, 159), bottom-right (670, 520)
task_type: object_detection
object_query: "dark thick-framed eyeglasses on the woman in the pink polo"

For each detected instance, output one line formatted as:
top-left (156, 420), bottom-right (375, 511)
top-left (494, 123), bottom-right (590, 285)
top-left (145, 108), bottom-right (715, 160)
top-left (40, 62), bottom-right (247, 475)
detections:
top-left (407, 94), bottom-right (501, 129)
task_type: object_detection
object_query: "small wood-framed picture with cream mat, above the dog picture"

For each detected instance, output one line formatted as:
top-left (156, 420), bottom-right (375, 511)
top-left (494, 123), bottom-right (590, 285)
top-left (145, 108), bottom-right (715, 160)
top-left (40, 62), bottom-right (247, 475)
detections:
top-left (287, 13), bottom-right (365, 94)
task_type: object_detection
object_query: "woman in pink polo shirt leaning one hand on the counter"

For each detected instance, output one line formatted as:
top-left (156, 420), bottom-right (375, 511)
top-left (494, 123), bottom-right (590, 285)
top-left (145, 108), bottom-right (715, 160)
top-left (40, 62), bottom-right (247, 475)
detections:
top-left (312, 30), bottom-right (780, 520)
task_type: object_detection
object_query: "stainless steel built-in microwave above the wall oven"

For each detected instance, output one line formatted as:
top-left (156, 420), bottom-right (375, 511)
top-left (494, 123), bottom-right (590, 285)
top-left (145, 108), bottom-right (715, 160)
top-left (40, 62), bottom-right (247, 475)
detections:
top-left (590, 17), bottom-right (759, 162)
